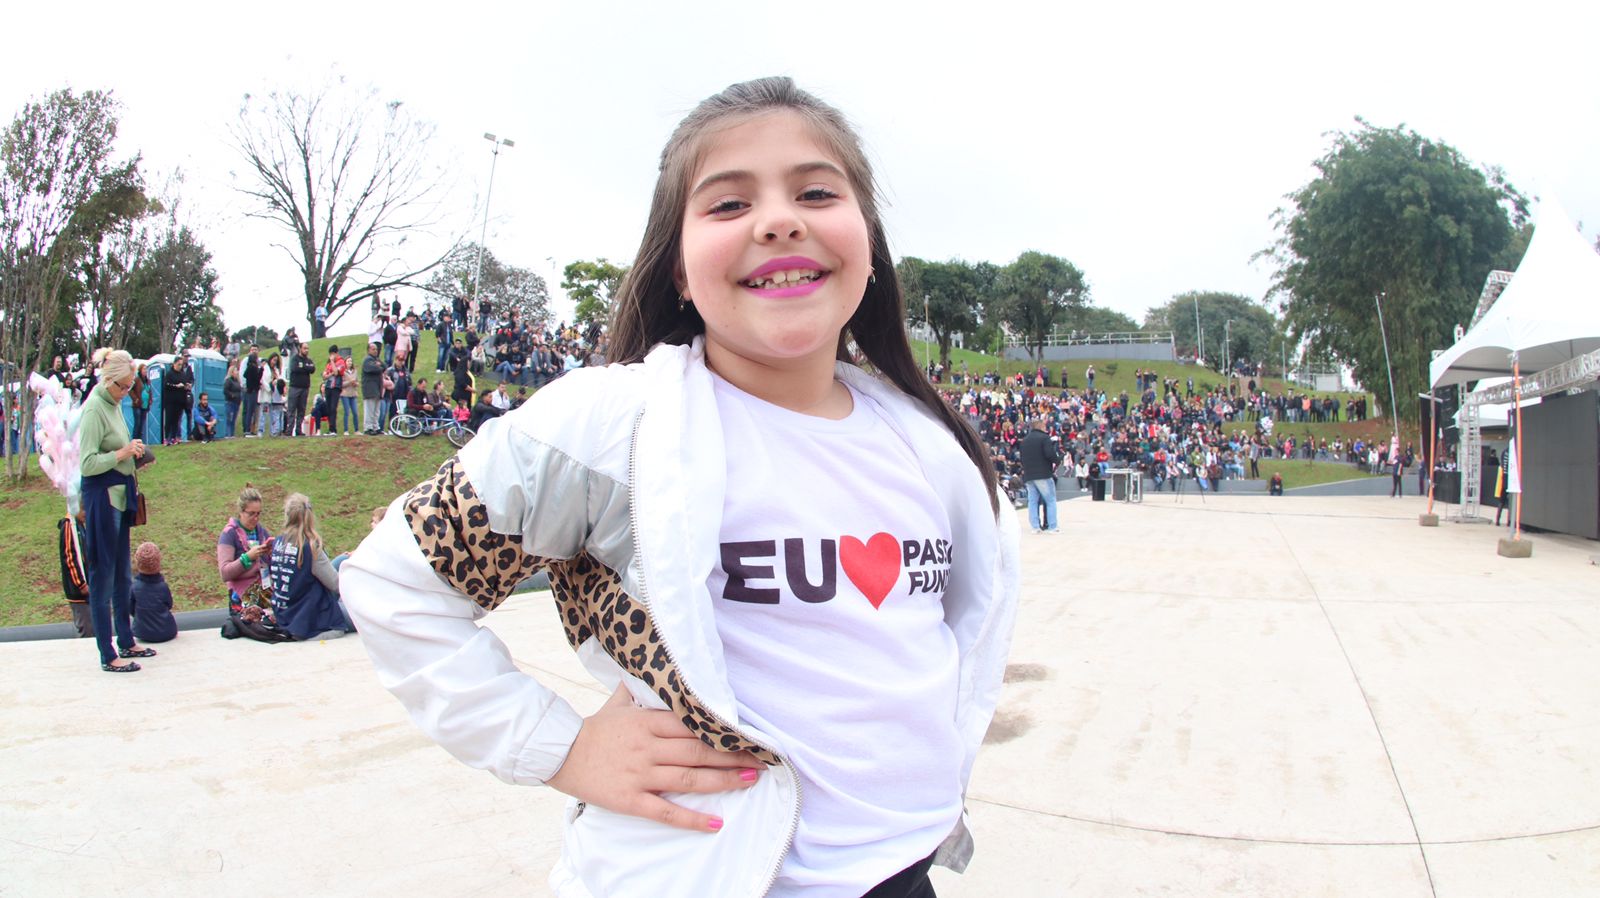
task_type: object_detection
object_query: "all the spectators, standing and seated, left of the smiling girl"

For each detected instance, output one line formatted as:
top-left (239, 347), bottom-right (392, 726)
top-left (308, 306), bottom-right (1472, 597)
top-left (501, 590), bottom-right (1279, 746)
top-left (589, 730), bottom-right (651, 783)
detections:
top-left (45, 301), bottom-right (606, 672)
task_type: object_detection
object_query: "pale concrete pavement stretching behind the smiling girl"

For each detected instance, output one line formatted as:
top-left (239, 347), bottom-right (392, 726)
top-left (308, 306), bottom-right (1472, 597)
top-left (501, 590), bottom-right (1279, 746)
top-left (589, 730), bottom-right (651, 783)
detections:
top-left (0, 493), bottom-right (1600, 898)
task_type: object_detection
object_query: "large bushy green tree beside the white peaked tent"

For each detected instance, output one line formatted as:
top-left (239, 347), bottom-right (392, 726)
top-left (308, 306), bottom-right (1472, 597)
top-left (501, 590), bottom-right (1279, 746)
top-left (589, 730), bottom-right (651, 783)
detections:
top-left (1262, 120), bottom-right (1528, 416)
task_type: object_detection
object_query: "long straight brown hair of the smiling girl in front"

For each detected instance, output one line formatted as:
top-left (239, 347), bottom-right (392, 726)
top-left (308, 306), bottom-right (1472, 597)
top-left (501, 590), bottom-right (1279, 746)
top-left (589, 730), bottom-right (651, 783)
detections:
top-left (610, 77), bottom-right (1000, 514)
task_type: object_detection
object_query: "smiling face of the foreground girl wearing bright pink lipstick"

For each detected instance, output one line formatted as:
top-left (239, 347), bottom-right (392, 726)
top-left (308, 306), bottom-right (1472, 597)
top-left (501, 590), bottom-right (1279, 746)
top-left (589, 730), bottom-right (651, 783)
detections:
top-left (680, 110), bottom-right (872, 368)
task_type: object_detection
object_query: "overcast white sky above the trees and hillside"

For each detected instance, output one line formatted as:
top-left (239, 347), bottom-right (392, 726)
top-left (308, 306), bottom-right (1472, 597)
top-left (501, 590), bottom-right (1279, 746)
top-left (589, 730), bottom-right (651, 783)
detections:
top-left (0, 0), bottom-right (1600, 333)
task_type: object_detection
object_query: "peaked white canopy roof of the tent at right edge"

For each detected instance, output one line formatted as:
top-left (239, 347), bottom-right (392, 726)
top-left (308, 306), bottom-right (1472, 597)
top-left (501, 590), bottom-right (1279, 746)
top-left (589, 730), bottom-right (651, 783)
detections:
top-left (1429, 200), bottom-right (1600, 387)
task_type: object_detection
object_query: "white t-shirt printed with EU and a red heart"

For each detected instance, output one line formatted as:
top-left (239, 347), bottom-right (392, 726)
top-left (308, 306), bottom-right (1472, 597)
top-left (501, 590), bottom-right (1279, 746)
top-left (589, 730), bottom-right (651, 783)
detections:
top-left (707, 378), bottom-right (962, 898)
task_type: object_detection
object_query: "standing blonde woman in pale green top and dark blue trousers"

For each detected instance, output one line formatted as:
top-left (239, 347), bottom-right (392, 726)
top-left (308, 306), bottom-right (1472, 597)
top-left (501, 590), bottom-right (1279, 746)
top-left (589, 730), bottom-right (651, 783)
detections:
top-left (78, 349), bottom-right (155, 674)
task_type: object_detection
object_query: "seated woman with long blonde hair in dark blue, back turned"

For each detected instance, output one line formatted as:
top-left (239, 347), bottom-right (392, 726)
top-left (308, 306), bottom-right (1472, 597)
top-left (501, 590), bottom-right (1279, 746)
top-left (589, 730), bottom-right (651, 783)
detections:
top-left (267, 493), bottom-right (355, 640)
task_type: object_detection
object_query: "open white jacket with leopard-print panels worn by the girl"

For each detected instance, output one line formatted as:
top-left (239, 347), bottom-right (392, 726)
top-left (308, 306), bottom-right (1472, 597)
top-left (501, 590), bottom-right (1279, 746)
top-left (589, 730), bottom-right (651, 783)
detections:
top-left (341, 339), bottom-right (1018, 898)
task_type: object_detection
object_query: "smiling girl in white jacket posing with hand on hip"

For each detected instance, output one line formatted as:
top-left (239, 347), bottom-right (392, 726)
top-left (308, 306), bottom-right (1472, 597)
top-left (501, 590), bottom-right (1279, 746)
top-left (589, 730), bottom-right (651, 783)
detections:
top-left (341, 78), bottom-right (1018, 898)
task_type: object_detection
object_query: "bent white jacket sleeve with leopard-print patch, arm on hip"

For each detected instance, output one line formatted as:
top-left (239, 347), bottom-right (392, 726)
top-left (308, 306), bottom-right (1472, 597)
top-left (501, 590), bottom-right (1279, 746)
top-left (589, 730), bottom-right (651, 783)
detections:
top-left (339, 421), bottom-right (587, 784)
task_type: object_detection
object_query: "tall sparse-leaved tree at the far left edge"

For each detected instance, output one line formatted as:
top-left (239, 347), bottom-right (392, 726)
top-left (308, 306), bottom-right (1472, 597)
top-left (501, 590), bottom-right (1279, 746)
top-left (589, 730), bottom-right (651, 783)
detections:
top-left (0, 90), bottom-right (118, 480)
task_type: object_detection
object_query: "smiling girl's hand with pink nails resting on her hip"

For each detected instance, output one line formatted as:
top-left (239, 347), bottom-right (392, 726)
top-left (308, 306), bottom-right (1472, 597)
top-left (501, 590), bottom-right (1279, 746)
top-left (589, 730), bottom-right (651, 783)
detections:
top-left (547, 687), bottom-right (763, 832)
